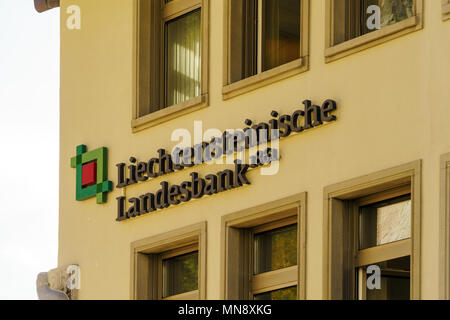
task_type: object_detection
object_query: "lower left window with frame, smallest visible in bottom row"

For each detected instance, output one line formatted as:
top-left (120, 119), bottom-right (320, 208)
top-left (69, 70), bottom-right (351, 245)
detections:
top-left (132, 223), bottom-right (206, 300)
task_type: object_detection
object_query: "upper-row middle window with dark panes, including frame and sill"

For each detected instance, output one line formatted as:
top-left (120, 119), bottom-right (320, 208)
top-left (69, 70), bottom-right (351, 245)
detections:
top-left (223, 0), bottom-right (309, 98)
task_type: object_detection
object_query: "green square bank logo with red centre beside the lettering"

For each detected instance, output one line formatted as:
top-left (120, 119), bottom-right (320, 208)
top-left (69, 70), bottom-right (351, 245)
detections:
top-left (70, 145), bottom-right (113, 204)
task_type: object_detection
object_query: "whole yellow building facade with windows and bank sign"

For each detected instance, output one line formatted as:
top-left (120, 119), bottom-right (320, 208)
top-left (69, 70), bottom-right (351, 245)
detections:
top-left (54, 0), bottom-right (450, 299)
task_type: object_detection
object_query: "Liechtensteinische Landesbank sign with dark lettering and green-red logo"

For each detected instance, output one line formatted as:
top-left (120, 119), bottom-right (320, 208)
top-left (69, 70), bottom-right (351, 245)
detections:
top-left (71, 99), bottom-right (337, 221)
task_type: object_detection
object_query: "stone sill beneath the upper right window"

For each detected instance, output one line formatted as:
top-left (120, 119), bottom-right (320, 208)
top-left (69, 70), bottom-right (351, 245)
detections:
top-left (325, 16), bottom-right (422, 63)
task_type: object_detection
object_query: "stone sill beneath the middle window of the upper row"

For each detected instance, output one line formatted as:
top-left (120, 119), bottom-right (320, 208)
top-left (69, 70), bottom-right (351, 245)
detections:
top-left (222, 57), bottom-right (308, 100)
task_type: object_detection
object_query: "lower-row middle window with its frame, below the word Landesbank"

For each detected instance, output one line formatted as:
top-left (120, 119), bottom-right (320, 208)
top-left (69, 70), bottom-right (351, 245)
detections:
top-left (222, 193), bottom-right (306, 300)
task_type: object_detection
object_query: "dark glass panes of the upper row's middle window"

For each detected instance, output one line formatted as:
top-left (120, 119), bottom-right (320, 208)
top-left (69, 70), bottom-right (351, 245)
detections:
top-left (229, 0), bottom-right (301, 83)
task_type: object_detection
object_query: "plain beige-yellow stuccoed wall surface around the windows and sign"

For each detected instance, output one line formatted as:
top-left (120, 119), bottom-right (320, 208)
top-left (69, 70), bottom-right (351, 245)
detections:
top-left (59, 0), bottom-right (450, 299)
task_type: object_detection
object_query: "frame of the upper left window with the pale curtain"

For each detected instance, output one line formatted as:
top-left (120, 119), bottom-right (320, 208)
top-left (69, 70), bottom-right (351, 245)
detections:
top-left (131, 0), bottom-right (210, 133)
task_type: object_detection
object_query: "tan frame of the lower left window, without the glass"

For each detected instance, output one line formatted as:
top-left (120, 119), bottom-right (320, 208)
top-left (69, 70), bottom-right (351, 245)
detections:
top-left (130, 222), bottom-right (206, 300)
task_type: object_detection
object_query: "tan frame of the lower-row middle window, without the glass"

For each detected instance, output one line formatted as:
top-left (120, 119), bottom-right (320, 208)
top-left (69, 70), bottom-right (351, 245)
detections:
top-left (220, 192), bottom-right (307, 300)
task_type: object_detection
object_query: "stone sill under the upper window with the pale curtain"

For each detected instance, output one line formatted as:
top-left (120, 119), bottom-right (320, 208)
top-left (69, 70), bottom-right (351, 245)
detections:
top-left (131, 94), bottom-right (209, 133)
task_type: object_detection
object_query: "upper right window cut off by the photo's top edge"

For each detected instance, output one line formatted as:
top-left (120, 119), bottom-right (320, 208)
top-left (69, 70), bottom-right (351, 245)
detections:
top-left (325, 0), bottom-right (423, 61)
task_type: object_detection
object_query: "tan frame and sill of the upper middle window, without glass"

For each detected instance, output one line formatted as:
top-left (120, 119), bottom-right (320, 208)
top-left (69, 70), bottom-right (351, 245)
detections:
top-left (222, 0), bottom-right (310, 100)
